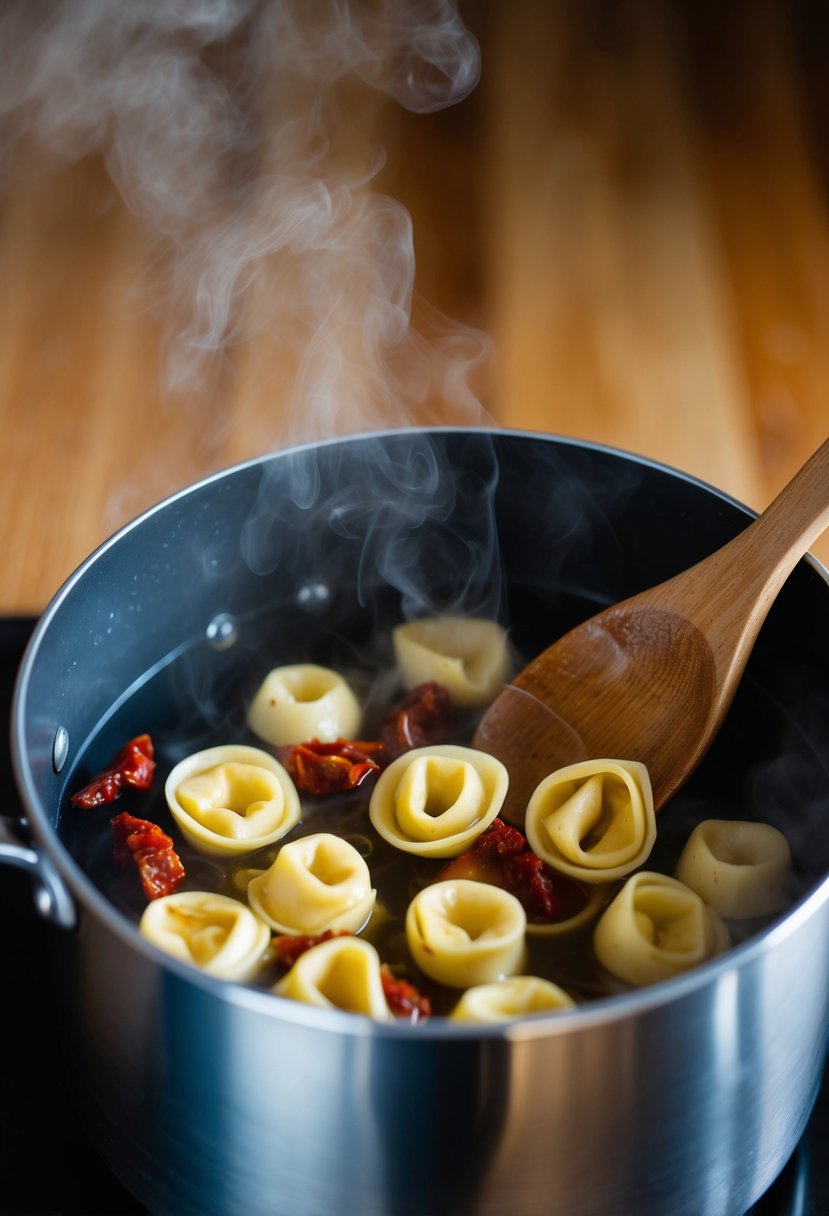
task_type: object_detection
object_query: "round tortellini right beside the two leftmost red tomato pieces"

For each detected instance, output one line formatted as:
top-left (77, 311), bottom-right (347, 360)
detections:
top-left (164, 744), bottom-right (299, 855)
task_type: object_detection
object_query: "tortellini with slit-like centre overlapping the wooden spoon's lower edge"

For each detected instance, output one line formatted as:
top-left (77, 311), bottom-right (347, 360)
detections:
top-left (524, 760), bottom-right (656, 883)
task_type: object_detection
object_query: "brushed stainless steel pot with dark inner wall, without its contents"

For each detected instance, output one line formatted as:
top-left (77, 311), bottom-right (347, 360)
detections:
top-left (6, 430), bottom-right (829, 1216)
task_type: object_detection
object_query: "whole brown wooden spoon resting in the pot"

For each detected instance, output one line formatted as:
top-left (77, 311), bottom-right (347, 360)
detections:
top-left (473, 440), bottom-right (829, 823)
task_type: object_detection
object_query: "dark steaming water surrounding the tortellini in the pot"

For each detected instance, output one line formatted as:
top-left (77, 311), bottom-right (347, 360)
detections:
top-left (60, 592), bottom-right (829, 1014)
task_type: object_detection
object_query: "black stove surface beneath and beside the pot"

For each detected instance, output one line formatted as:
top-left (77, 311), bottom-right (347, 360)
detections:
top-left (0, 618), bottom-right (829, 1216)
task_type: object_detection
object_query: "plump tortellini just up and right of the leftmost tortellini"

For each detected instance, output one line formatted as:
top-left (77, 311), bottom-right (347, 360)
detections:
top-left (248, 832), bottom-right (377, 934)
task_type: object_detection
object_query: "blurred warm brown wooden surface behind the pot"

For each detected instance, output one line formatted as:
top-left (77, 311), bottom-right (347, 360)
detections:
top-left (0, 0), bottom-right (829, 613)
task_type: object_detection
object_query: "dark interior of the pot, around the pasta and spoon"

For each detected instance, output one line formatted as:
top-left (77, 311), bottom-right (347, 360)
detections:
top-left (18, 432), bottom-right (829, 1013)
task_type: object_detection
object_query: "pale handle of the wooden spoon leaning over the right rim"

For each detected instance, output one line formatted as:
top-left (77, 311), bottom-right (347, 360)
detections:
top-left (655, 439), bottom-right (829, 685)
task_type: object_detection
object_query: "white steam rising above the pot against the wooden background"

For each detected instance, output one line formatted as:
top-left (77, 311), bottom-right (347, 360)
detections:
top-left (0, 0), bottom-right (487, 440)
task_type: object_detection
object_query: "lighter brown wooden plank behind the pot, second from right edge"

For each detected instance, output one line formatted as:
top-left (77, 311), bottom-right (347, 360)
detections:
top-left (478, 0), bottom-right (760, 501)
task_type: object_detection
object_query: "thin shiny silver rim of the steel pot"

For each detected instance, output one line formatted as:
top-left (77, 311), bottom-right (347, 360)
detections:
top-left (11, 426), bottom-right (829, 1042)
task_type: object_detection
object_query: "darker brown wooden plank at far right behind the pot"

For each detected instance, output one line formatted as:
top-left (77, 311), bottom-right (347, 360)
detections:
top-left (683, 0), bottom-right (829, 500)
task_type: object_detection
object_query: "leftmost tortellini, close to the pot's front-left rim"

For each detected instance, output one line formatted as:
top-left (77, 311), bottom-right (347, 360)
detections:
top-left (139, 891), bottom-right (271, 980)
